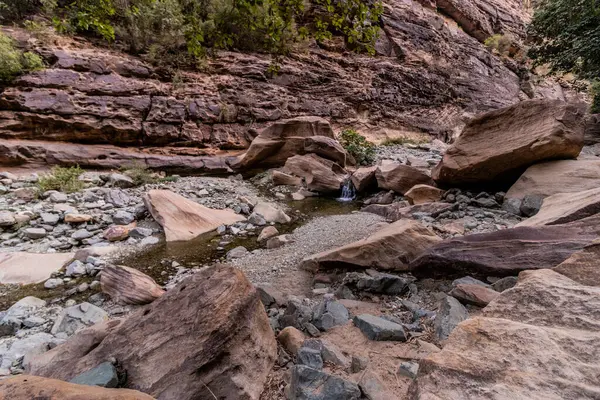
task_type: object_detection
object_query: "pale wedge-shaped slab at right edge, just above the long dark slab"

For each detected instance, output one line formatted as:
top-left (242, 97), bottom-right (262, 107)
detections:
top-left (517, 188), bottom-right (600, 226)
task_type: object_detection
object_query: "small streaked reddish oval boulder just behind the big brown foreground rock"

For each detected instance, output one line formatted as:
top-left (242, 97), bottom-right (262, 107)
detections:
top-left (100, 265), bottom-right (165, 304)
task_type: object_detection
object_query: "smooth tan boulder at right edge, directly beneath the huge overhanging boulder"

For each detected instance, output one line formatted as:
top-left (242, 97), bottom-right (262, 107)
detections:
top-left (505, 160), bottom-right (600, 200)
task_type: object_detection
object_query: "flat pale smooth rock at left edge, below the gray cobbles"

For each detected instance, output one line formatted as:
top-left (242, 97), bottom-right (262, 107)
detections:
top-left (0, 252), bottom-right (73, 285)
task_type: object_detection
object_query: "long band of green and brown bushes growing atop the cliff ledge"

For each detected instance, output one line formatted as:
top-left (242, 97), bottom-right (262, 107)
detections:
top-left (0, 0), bottom-right (383, 62)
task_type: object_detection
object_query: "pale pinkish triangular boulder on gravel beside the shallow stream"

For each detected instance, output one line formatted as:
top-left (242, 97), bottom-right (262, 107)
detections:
top-left (144, 190), bottom-right (245, 242)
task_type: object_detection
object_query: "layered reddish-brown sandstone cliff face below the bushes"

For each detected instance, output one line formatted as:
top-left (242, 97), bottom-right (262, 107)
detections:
top-left (0, 0), bottom-right (526, 168)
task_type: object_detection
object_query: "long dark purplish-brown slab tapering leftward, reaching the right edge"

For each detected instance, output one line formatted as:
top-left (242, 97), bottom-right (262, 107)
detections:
top-left (410, 215), bottom-right (600, 276)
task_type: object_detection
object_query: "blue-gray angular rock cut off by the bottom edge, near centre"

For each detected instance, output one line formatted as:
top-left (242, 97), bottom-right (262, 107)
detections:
top-left (288, 365), bottom-right (361, 400)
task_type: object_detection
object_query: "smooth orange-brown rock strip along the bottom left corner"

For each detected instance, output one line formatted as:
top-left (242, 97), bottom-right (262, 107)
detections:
top-left (0, 375), bottom-right (154, 400)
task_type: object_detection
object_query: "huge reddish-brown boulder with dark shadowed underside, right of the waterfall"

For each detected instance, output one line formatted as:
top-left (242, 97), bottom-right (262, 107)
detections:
top-left (432, 100), bottom-right (584, 186)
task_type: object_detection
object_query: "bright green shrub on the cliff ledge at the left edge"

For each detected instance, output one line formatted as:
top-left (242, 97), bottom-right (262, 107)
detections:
top-left (0, 32), bottom-right (44, 85)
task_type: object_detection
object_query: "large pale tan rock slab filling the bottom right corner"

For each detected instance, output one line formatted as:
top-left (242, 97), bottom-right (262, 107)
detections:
top-left (409, 266), bottom-right (600, 400)
